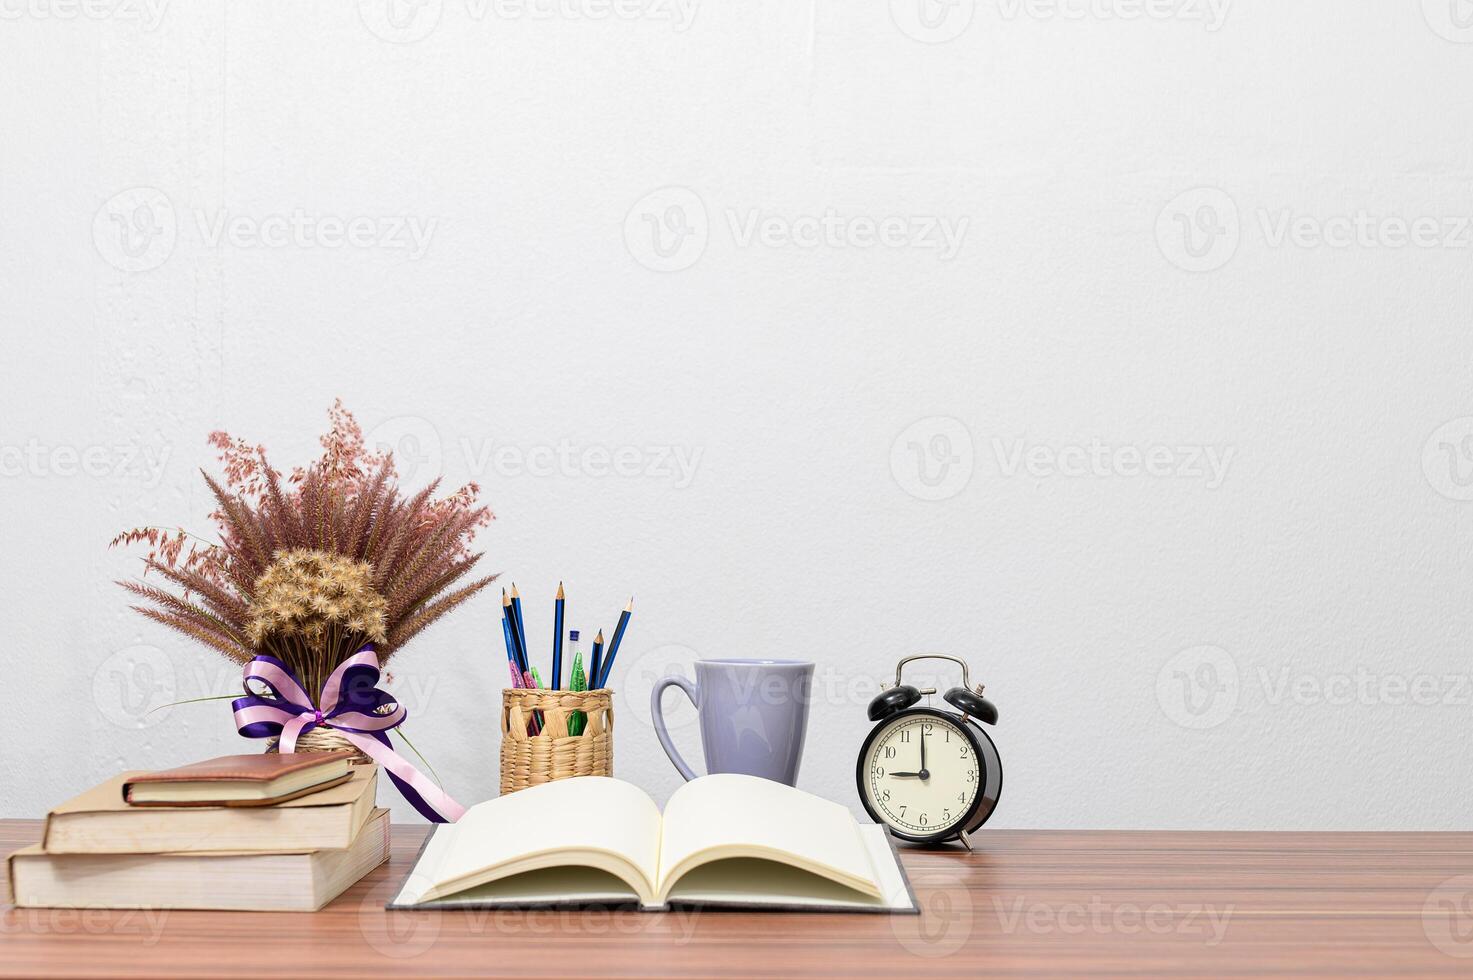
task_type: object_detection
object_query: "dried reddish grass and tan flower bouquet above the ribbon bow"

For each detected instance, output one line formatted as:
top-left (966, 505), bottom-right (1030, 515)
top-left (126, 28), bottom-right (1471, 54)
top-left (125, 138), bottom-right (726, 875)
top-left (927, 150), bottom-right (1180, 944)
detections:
top-left (112, 401), bottom-right (495, 696)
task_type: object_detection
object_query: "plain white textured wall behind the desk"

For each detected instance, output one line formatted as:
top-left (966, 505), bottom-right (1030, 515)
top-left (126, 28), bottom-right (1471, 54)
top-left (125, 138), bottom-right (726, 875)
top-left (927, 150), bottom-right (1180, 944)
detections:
top-left (0, 0), bottom-right (1473, 830)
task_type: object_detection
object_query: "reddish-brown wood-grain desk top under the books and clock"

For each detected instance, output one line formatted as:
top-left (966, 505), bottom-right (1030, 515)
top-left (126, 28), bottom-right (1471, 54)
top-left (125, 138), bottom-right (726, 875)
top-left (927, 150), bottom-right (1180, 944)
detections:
top-left (0, 821), bottom-right (1473, 980)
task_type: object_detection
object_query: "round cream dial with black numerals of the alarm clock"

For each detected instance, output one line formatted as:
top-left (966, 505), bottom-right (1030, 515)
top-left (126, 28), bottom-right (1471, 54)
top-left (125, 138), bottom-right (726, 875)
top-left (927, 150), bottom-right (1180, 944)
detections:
top-left (859, 712), bottom-right (985, 839)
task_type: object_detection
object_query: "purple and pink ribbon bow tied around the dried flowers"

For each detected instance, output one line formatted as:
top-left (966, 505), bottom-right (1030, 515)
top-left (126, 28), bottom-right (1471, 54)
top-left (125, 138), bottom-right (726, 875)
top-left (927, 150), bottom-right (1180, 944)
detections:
top-left (230, 644), bottom-right (465, 824)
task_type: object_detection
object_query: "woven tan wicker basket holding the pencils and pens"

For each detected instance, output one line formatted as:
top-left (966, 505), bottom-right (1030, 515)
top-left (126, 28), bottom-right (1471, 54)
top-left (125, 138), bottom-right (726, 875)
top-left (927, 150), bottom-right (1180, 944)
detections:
top-left (501, 688), bottom-right (614, 796)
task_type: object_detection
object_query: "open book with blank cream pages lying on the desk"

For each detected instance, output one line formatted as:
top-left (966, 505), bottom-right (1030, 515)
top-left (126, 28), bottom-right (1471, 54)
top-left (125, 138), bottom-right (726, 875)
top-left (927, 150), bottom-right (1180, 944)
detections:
top-left (389, 774), bottom-right (916, 912)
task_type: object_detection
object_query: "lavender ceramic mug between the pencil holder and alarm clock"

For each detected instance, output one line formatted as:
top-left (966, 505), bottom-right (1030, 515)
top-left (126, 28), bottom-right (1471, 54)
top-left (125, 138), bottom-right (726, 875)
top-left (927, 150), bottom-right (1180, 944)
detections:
top-left (650, 660), bottom-right (813, 785)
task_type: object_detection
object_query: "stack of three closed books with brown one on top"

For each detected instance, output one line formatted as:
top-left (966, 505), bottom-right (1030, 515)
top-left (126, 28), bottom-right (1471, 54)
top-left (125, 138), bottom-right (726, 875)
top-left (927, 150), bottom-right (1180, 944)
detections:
top-left (6, 753), bottom-right (389, 911)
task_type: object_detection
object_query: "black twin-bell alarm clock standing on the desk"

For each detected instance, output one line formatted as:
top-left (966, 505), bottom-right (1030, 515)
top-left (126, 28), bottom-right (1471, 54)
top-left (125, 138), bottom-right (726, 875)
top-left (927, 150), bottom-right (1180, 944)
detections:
top-left (854, 654), bottom-right (1003, 849)
